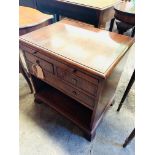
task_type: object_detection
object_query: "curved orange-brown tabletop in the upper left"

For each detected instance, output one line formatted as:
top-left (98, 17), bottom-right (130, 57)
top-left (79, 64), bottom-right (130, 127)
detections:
top-left (19, 6), bottom-right (53, 28)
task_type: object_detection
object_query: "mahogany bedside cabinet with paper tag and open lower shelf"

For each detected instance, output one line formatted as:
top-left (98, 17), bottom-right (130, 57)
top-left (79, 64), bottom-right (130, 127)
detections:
top-left (20, 21), bottom-right (134, 140)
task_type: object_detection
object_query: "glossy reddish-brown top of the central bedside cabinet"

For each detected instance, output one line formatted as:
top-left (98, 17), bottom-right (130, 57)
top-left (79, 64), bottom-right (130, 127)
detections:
top-left (20, 22), bottom-right (133, 77)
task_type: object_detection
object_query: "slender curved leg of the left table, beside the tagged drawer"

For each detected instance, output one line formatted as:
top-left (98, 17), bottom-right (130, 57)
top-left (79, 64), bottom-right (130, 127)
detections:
top-left (19, 58), bottom-right (33, 93)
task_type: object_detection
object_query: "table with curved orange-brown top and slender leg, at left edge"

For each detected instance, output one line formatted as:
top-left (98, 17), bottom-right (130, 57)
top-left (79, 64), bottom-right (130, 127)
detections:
top-left (19, 6), bottom-right (53, 93)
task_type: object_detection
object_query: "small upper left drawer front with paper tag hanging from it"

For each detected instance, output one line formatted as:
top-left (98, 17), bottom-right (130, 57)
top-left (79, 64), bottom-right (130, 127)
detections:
top-left (25, 52), bottom-right (54, 73)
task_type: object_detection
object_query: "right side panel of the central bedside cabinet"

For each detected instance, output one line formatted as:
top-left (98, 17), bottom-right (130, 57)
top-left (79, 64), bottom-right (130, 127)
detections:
top-left (91, 49), bottom-right (129, 129)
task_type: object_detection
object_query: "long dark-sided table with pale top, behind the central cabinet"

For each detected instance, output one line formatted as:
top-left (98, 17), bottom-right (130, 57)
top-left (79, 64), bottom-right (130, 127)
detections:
top-left (36, 0), bottom-right (120, 27)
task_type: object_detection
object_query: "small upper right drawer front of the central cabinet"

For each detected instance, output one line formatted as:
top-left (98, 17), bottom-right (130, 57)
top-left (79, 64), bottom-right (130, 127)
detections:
top-left (56, 67), bottom-right (97, 96)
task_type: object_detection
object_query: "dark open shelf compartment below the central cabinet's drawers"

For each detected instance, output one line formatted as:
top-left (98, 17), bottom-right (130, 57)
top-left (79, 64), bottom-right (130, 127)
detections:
top-left (32, 76), bottom-right (92, 132)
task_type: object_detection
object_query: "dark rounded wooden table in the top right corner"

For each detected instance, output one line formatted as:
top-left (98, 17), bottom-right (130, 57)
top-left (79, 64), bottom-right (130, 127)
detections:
top-left (109, 1), bottom-right (135, 36)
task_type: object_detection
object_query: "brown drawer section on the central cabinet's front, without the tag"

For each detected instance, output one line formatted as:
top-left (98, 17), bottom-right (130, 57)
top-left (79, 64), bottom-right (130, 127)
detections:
top-left (25, 47), bottom-right (97, 108)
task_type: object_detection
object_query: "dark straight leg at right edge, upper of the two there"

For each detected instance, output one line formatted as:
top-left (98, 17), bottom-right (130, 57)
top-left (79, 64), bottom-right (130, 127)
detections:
top-left (117, 70), bottom-right (135, 111)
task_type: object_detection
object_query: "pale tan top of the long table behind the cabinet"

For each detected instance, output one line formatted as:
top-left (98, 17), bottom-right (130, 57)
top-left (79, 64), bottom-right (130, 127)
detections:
top-left (57, 0), bottom-right (120, 9)
